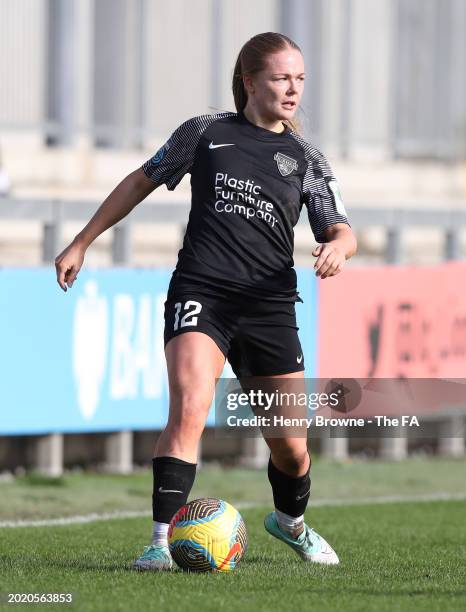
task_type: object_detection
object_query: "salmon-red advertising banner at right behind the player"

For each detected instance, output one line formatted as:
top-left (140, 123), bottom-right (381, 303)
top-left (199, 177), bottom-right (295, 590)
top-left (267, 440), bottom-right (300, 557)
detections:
top-left (317, 262), bottom-right (466, 378)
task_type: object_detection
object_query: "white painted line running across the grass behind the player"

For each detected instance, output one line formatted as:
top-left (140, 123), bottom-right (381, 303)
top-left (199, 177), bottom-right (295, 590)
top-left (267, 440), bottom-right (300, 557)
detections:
top-left (0, 491), bottom-right (466, 529)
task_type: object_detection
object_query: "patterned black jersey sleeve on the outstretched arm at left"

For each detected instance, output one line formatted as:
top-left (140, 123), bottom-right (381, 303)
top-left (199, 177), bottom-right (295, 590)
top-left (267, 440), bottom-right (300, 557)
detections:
top-left (142, 113), bottom-right (229, 191)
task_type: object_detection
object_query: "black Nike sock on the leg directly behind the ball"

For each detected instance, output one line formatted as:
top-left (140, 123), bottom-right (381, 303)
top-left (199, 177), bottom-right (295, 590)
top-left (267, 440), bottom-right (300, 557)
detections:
top-left (152, 457), bottom-right (197, 523)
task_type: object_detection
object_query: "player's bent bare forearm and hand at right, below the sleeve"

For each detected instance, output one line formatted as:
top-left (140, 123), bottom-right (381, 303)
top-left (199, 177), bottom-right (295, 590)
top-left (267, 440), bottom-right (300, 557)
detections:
top-left (312, 223), bottom-right (357, 278)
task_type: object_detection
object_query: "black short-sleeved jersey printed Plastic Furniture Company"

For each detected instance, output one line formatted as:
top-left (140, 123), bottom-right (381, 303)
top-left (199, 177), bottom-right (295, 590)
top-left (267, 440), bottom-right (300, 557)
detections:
top-left (142, 112), bottom-right (349, 299)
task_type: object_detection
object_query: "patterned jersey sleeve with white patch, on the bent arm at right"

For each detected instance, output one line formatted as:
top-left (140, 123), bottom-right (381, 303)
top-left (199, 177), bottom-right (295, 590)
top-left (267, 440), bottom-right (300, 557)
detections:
top-left (302, 147), bottom-right (351, 242)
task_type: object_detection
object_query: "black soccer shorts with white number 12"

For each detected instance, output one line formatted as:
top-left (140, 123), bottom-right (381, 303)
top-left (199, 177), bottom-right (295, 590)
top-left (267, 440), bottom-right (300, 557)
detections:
top-left (164, 282), bottom-right (304, 379)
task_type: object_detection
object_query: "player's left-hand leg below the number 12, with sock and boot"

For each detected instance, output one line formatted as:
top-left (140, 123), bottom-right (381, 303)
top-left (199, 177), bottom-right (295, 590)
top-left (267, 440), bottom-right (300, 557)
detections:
top-left (133, 331), bottom-right (225, 570)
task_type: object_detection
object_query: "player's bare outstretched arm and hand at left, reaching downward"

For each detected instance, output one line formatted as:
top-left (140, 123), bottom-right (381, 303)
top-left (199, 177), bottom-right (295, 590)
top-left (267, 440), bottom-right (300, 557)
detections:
top-left (55, 168), bottom-right (157, 291)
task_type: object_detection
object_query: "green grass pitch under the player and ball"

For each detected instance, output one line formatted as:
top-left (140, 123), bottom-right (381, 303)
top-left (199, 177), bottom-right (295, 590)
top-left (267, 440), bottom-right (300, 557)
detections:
top-left (0, 462), bottom-right (466, 612)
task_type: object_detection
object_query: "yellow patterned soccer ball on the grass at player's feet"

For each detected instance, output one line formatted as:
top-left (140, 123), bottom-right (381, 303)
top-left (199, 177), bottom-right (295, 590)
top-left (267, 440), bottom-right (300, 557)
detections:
top-left (168, 497), bottom-right (248, 572)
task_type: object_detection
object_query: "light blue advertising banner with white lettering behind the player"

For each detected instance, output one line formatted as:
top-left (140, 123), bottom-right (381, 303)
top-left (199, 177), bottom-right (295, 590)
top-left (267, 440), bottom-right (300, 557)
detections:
top-left (0, 268), bottom-right (317, 435)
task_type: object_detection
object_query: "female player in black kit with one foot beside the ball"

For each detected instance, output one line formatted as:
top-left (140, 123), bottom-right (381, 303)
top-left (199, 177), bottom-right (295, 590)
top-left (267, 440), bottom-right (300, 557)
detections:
top-left (56, 32), bottom-right (356, 570)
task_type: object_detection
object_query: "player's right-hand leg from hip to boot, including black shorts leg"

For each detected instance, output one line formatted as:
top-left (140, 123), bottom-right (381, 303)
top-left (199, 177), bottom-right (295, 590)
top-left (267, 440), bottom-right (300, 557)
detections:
top-left (228, 301), bottom-right (338, 563)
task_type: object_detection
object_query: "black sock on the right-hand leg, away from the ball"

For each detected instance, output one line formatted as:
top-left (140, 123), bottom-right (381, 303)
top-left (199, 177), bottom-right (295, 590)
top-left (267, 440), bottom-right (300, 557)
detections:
top-left (268, 457), bottom-right (311, 516)
